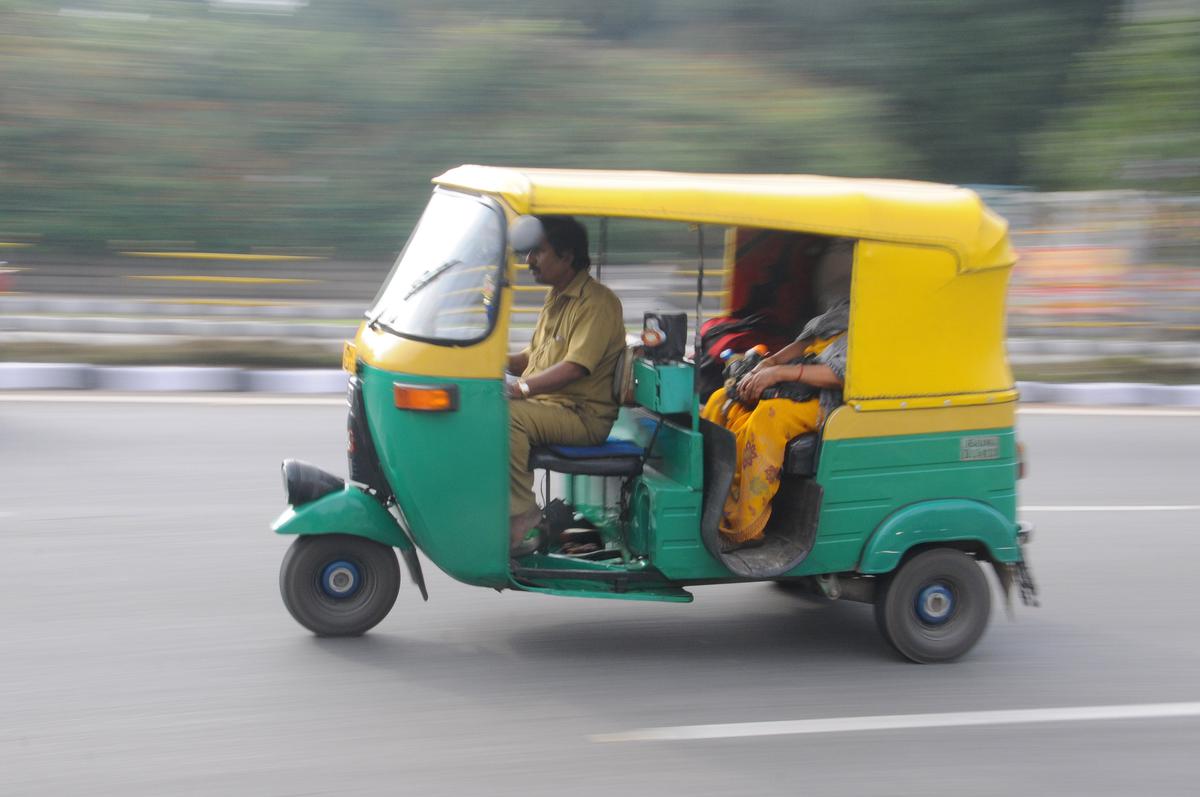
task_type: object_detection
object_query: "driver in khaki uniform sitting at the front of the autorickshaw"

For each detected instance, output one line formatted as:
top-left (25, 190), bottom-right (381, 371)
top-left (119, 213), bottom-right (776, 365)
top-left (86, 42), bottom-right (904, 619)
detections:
top-left (508, 216), bottom-right (625, 556)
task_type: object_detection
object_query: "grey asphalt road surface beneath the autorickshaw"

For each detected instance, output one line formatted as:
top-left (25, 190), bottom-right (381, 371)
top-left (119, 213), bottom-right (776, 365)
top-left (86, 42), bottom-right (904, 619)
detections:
top-left (0, 396), bottom-right (1200, 797)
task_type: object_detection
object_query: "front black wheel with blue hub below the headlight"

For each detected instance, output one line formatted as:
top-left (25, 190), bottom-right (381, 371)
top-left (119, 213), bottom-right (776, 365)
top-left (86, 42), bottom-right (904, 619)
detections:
top-left (280, 534), bottom-right (400, 636)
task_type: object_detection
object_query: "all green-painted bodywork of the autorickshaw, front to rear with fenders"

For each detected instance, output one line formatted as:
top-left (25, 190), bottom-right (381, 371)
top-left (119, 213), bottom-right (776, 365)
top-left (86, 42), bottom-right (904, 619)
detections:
top-left (343, 352), bottom-right (1020, 590)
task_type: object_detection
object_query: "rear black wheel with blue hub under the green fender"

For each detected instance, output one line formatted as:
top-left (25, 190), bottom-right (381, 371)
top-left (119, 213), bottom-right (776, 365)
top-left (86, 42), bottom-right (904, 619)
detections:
top-left (875, 549), bottom-right (991, 664)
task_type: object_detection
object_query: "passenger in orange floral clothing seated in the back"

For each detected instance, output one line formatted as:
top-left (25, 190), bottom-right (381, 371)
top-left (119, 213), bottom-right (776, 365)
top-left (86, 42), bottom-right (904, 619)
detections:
top-left (702, 299), bottom-right (850, 550)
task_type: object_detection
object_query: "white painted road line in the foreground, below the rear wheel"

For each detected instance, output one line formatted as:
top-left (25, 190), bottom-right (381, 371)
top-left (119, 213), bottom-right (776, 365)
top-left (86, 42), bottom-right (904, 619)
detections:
top-left (590, 702), bottom-right (1200, 742)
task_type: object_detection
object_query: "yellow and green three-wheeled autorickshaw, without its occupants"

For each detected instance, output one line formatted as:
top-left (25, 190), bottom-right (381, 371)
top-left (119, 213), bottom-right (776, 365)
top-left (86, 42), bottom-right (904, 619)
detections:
top-left (267, 166), bottom-right (1036, 663)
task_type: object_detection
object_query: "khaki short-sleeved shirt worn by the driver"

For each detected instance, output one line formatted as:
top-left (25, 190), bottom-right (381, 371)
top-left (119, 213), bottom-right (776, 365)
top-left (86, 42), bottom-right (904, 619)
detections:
top-left (521, 270), bottom-right (625, 424)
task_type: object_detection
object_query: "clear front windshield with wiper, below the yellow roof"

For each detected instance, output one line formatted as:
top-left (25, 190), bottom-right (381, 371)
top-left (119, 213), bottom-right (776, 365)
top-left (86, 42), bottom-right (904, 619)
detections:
top-left (367, 190), bottom-right (504, 343)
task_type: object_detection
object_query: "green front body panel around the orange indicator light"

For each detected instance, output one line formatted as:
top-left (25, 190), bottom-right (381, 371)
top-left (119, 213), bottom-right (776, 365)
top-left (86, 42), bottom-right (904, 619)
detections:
top-left (359, 365), bottom-right (509, 587)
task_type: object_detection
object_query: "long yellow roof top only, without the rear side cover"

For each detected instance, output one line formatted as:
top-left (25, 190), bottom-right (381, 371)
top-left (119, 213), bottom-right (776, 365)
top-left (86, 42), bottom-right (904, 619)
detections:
top-left (433, 166), bottom-right (1016, 272)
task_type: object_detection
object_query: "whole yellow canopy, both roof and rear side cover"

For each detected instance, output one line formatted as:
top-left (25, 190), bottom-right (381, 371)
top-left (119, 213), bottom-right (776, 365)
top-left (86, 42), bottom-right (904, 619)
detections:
top-left (434, 166), bottom-right (1016, 411)
